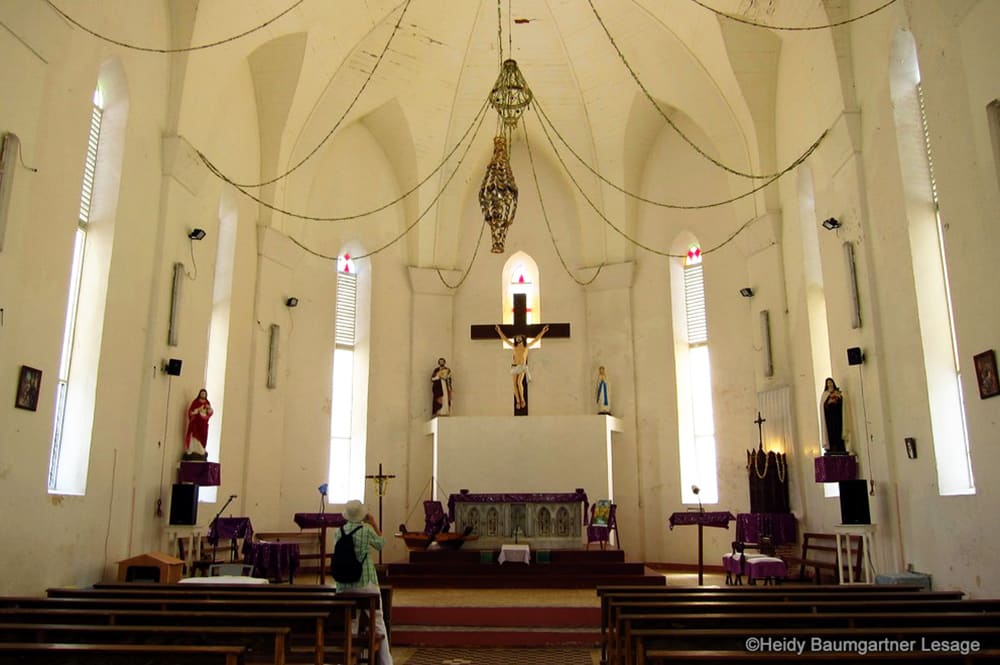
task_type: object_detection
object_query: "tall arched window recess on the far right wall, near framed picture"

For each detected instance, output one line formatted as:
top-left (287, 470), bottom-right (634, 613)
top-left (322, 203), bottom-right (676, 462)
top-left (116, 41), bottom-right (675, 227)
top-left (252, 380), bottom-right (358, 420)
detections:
top-left (890, 30), bottom-right (976, 496)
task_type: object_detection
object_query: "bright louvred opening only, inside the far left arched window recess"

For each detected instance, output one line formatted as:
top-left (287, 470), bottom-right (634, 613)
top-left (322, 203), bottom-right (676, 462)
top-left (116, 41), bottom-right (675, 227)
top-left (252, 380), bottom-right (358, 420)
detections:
top-left (48, 86), bottom-right (104, 494)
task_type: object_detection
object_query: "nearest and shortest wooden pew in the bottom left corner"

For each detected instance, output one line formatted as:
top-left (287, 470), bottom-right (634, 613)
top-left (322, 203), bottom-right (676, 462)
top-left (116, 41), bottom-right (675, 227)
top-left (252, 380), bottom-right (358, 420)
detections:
top-left (0, 642), bottom-right (243, 665)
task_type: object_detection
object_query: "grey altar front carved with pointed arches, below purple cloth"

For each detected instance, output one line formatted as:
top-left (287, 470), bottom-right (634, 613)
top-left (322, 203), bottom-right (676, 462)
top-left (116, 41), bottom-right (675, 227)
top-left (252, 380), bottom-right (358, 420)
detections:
top-left (448, 490), bottom-right (587, 549)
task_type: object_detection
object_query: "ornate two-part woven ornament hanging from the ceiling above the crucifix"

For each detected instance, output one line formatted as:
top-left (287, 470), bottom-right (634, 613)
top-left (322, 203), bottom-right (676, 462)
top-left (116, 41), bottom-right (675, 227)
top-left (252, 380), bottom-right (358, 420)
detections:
top-left (479, 59), bottom-right (532, 254)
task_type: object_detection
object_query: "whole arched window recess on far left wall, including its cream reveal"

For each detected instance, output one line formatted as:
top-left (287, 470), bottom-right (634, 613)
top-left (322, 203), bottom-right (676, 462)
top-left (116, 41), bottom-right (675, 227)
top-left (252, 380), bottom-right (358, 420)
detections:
top-left (48, 66), bottom-right (128, 495)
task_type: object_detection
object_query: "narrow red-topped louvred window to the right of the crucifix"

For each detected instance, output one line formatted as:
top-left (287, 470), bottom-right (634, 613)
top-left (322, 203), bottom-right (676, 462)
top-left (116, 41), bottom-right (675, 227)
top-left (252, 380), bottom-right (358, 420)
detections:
top-left (674, 244), bottom-right (719, 503)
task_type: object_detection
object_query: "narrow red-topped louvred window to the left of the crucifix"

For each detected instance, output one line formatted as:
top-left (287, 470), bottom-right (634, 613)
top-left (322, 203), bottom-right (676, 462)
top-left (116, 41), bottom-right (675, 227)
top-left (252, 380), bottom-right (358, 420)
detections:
top-left (329, 254), bottom-right (365, 503)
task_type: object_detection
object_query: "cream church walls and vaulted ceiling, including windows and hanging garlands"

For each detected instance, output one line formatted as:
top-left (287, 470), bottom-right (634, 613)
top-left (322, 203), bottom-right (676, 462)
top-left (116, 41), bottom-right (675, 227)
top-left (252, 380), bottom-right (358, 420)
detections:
top-left (0, 0), bottom-right (1000, 632)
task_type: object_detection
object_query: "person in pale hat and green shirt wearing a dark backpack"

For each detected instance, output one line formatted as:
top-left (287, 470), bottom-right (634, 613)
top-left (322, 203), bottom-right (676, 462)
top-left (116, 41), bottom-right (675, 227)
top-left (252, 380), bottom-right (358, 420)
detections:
top-left (340, 499), bottom-right (392, 665)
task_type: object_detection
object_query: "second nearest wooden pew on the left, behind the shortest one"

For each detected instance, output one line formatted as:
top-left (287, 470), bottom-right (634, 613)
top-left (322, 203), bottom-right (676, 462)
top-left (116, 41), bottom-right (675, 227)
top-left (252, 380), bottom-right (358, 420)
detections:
top-left (0, 623), bottom-right (291, 665)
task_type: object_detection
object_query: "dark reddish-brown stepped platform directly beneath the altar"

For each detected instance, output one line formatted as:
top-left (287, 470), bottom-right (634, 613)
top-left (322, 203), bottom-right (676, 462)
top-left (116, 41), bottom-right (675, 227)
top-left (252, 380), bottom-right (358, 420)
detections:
top-left (382, 549), bottom-right (666, 589)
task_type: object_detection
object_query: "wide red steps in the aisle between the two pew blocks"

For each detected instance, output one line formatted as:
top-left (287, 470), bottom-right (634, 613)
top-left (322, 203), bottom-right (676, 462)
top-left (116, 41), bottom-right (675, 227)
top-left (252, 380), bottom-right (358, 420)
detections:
top-left (392, 607), bottom-right (601, 647)
